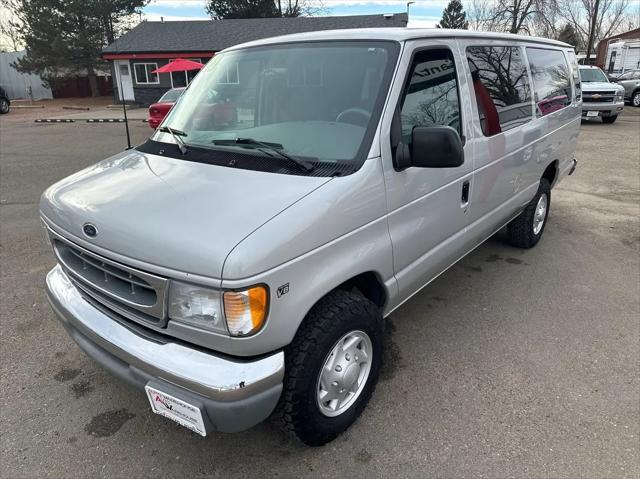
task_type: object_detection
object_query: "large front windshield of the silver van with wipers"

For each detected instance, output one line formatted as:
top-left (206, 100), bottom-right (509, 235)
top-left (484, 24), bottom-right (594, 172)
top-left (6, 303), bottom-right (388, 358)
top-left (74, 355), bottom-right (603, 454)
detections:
top-left (153, 41), bottom-right (399, 172)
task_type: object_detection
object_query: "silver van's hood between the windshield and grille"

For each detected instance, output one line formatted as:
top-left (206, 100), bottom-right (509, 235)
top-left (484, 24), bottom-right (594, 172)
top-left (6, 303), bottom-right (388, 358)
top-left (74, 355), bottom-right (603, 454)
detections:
top-left (40, 150), bottom-right (331, 279)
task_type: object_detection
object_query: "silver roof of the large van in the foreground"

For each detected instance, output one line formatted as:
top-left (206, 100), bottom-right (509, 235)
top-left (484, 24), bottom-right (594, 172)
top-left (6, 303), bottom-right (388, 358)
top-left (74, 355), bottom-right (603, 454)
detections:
top-left (229, 27), bottom-right (573, 50)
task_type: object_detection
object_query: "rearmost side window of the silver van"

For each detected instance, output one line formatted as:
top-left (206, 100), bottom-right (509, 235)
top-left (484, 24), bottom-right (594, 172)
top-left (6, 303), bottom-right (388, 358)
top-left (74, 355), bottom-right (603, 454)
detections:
top-left (527, 48), bottom-right (571, 116)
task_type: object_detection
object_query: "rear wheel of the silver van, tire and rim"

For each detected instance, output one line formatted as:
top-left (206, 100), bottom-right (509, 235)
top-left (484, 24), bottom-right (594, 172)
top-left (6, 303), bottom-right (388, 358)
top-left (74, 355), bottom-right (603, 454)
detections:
top-left (507, 178), bottom-right (551, 248)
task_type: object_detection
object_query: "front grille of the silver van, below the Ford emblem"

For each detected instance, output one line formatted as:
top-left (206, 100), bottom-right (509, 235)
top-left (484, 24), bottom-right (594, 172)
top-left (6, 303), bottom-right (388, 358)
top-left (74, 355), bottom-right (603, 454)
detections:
top-left (49, 230), bottom-right (168, 327)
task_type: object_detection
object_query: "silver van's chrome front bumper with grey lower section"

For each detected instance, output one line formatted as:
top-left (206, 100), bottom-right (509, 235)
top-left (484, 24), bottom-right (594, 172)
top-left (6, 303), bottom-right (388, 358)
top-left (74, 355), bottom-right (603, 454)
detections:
top-left (46, 265), bottom-right (284, 432)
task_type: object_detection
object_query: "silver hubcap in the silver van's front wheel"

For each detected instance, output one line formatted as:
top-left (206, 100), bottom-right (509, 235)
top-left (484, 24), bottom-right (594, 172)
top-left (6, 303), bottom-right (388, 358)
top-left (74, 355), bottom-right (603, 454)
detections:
top-left (316, 331), bottom-right (373, 417)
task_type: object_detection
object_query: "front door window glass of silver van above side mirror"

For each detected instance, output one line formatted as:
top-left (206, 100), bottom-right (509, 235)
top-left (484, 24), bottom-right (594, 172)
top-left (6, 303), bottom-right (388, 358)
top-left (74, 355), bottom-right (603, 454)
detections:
top-left (400, 50), bottom-right (461, 145)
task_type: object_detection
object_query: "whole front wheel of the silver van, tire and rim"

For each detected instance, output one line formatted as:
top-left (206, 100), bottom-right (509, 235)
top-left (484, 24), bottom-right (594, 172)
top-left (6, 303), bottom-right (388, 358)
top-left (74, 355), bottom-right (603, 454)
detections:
top-left (276, 290), bottom-right (384, 446)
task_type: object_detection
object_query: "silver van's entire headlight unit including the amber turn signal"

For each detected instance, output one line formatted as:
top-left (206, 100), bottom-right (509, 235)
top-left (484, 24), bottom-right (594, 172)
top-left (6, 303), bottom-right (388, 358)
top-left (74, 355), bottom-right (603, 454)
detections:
top-left (169, 281), bottom-right (269, 336)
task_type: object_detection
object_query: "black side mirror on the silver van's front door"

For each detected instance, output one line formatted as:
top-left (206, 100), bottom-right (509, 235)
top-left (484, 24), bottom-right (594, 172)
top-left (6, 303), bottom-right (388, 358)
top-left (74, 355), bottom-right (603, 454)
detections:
top-left (395, 126), bottom-right (464, 170)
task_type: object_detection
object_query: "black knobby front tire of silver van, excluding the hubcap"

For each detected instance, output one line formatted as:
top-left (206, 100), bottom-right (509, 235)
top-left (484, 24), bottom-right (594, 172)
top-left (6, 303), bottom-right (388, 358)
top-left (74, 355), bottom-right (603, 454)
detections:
top-left (274, 290), bottom-right (384, 446)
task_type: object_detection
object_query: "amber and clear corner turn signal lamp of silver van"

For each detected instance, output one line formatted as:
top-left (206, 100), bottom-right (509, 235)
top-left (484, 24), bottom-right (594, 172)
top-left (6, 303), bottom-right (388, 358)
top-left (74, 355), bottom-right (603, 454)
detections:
top-left (224, 286), bottom-right (269, 336)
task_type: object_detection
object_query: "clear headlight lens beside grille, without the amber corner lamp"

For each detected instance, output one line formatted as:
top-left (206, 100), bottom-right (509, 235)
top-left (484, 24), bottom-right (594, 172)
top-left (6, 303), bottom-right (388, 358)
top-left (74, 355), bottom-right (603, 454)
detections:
top-left (169, 281), bottom-right (227, 334)
